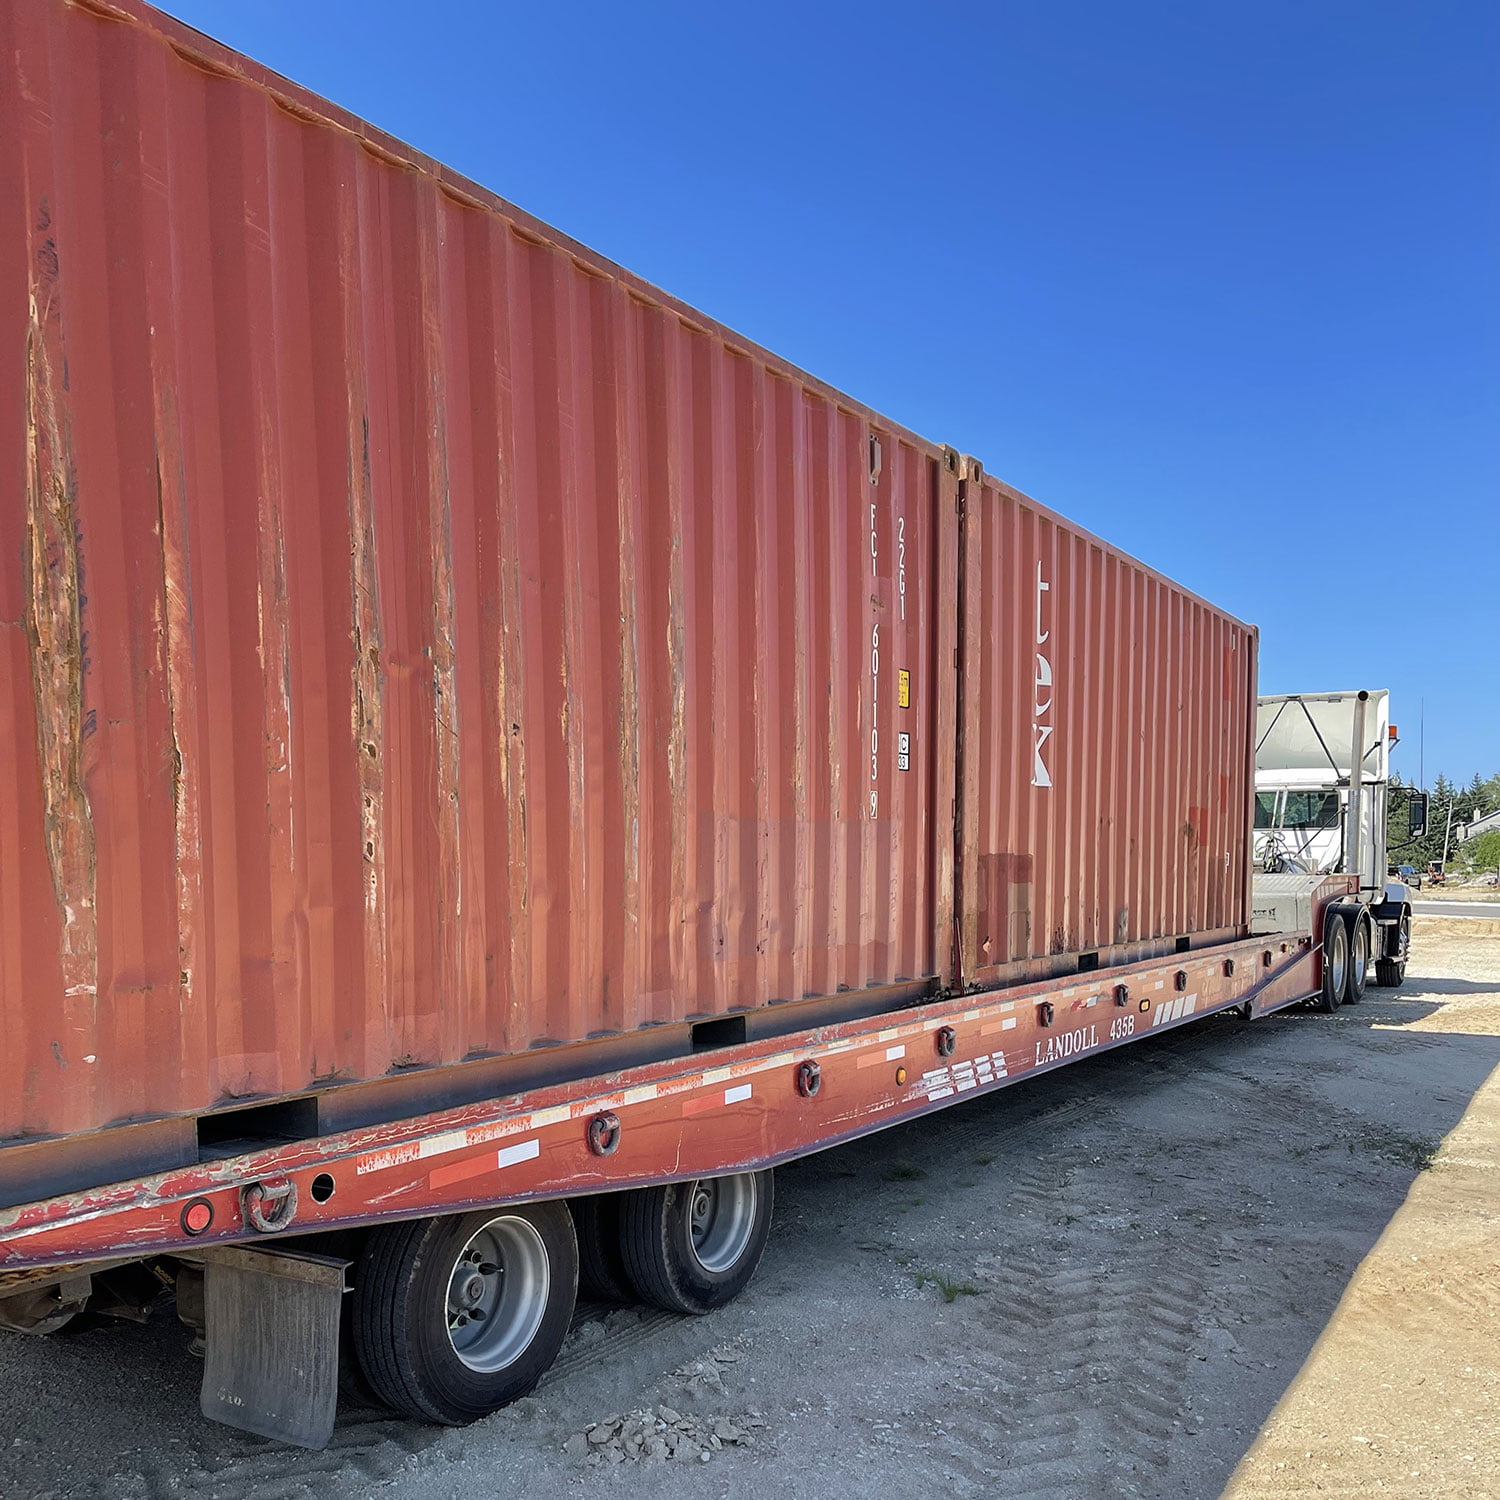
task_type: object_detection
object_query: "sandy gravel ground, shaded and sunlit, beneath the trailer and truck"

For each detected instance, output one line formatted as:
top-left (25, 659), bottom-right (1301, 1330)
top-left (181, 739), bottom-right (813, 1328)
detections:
top-left (0, 923), bottom-right (1500, 1500)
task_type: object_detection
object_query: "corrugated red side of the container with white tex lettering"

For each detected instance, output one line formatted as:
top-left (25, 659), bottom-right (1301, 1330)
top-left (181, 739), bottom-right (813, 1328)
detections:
top-left (960, 476), bottom-right (1256, 986)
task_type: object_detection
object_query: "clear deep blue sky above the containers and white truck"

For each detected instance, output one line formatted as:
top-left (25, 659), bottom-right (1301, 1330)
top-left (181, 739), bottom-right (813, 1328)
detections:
top-left (168, 0), bottom-right (1500, 782)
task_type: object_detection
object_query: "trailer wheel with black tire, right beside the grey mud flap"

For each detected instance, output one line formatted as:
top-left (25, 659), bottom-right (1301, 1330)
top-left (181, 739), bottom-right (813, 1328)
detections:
top-left (353, 1203), bottom-right (578, 1427)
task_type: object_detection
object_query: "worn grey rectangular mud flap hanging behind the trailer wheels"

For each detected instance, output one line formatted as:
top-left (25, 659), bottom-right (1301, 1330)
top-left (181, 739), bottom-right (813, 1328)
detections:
top-left (194, 1245), bottom-right (348, 1448)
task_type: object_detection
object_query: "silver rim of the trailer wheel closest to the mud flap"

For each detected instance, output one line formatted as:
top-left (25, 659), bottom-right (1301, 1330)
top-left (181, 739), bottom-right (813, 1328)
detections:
top-left (446, 1214), bottom-right (552, 1374)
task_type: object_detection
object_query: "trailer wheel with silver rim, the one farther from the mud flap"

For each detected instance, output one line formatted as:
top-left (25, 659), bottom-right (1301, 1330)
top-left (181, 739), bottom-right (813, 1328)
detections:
top-left (620, 1172), bottom-right (774, 1313)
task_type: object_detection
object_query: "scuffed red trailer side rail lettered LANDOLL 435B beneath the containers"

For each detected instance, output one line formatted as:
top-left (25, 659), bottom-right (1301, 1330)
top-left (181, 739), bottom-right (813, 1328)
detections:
top-left (0, 933), bottom-right (1316, 1271)
